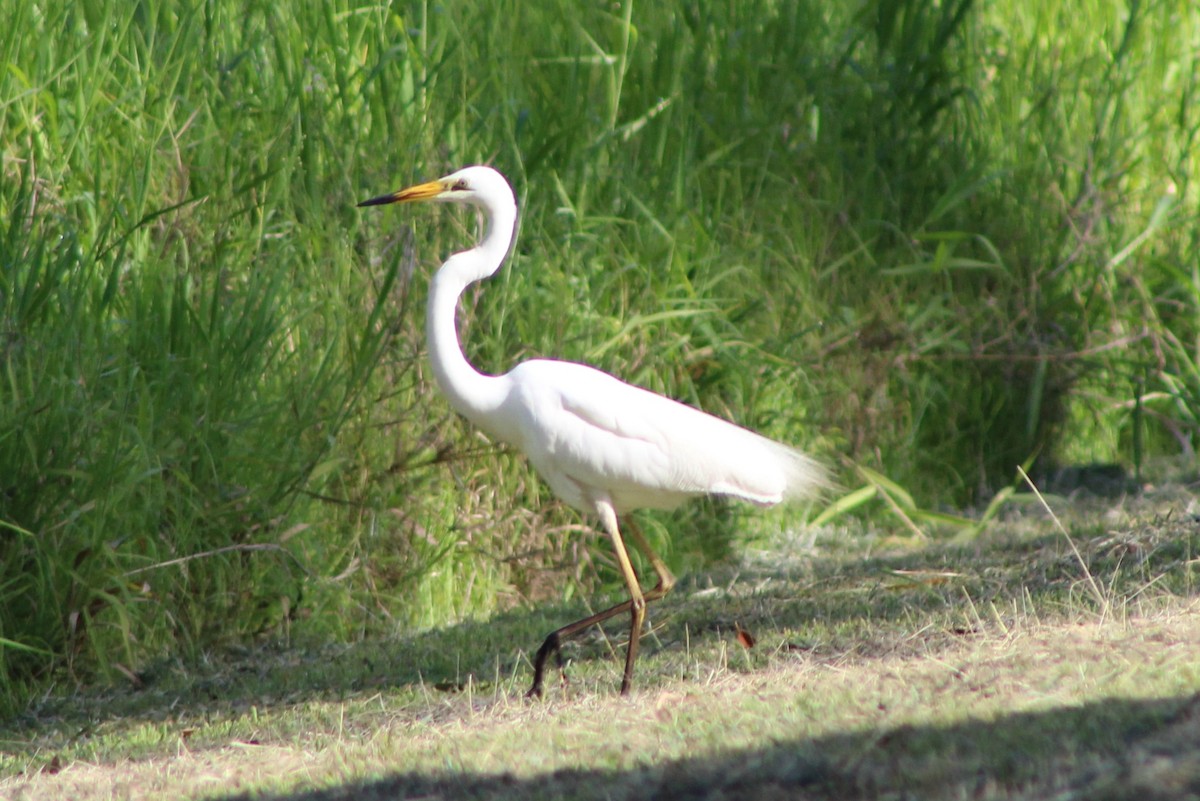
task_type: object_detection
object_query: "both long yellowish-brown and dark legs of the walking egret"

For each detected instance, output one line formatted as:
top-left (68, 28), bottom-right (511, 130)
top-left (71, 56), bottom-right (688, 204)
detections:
top-left (527, 514), bottom-right (676, 698)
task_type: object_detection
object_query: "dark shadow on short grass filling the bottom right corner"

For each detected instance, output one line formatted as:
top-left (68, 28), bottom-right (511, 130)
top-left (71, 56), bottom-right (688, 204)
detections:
top-left (216, 694), bottom-right (1200, 801)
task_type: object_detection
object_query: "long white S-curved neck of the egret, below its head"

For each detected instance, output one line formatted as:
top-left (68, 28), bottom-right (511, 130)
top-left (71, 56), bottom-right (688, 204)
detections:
top-left (425, 206), bottom-right (516, 438)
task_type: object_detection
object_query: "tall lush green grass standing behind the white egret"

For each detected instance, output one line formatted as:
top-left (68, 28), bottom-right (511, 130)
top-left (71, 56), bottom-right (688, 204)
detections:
top-left (0, 0), bottom-right (1200, 712)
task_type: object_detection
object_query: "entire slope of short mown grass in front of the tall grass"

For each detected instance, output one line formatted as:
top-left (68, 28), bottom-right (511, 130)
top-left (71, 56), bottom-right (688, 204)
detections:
top-left (0, 484), bottom-right (1200, 801)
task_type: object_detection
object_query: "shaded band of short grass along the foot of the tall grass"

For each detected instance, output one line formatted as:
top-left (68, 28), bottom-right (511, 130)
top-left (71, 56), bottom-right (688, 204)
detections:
top-left (9, 506), bottom-right (1200, 751)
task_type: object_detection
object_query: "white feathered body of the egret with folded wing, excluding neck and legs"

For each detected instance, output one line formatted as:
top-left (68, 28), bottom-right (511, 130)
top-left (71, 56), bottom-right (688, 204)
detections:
top-left (509, 360), bottom-right (822, 508)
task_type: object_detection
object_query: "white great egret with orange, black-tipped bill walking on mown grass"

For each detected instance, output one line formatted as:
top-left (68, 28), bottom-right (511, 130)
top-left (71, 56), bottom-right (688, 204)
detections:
top-left (359, 167), bottom-right (824, 697)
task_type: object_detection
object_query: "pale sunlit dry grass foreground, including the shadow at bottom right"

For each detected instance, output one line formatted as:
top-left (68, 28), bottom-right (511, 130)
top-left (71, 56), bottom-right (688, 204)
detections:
top-left (9, 602), bottom-right (1200, 799)
